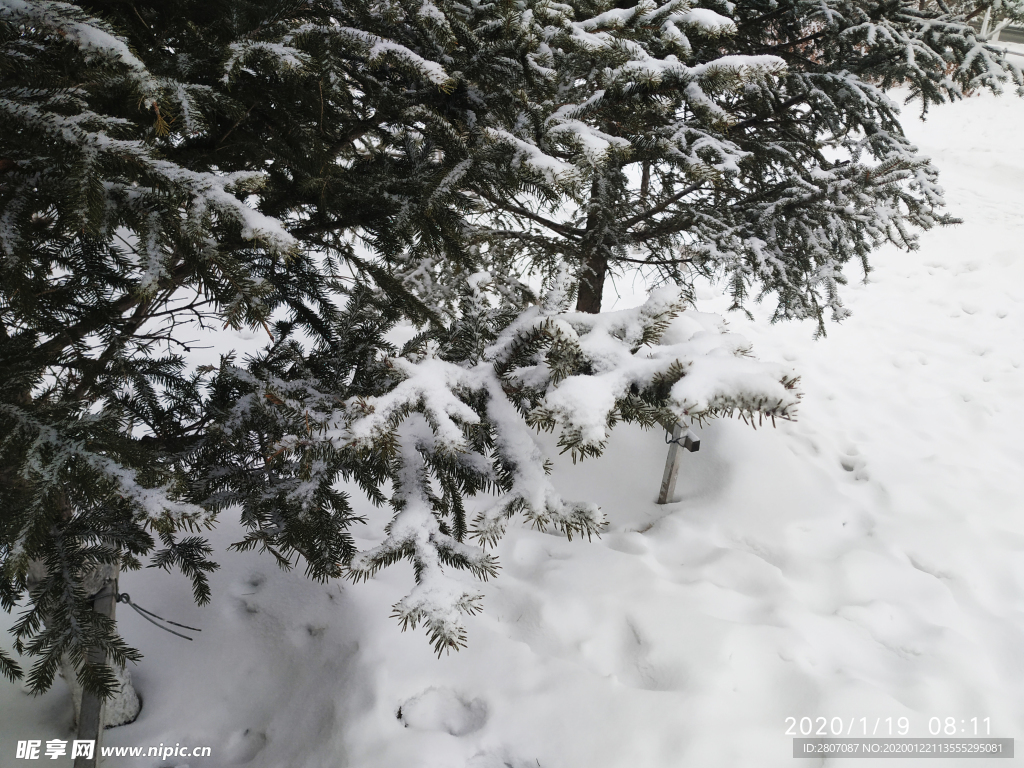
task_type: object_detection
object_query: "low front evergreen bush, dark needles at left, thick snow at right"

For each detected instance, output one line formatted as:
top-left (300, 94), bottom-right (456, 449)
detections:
top-left (194, 273), bottom-right (798, 651)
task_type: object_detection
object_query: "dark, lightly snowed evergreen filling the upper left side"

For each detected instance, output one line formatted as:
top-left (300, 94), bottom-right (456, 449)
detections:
top-left (0, 0), bottom-right (479, 693)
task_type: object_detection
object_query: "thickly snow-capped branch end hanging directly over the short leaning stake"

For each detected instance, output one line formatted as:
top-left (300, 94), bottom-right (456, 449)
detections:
top-left (487, 288), bottom-right (798, 456)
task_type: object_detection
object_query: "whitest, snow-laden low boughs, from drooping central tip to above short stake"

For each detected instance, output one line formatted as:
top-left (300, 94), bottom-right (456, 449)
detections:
top-left (292, 272), bottom-right (800, 653)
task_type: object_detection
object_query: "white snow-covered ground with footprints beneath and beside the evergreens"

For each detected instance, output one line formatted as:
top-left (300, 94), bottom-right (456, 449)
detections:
top-left (0, 88), bottom-right (1024, 768)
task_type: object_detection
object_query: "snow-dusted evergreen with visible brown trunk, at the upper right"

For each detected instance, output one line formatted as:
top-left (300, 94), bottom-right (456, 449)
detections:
top-left (466, 0), bottom-right (1024, 321)
